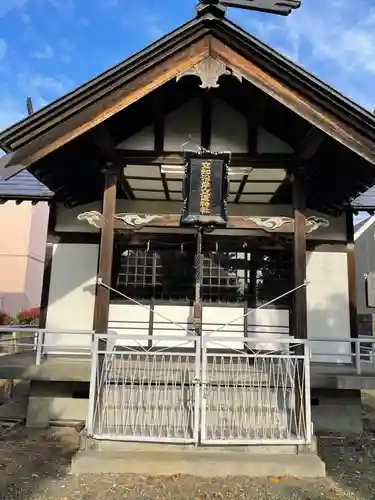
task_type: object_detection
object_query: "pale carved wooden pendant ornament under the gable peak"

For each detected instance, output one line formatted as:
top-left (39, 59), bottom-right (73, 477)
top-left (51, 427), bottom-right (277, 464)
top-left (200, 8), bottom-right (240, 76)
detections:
top-left (176, 56), bottom-right (242, 89)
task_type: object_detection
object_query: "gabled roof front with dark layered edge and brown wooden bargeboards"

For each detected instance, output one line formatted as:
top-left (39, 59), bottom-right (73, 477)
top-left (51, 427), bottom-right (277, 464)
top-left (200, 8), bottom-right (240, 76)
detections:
top-left (0, 5), bottom-right (375, 213)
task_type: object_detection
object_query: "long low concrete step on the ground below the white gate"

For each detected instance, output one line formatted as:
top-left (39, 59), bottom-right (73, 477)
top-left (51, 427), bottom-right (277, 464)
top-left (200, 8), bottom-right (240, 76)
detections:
top-left (71, 445), bottom-right (326, 478)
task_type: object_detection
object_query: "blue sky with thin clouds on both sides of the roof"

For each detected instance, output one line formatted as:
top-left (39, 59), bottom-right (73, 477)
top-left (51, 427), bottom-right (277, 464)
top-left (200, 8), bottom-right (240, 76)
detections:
top-left (0, 0), bottom-right (375, 129)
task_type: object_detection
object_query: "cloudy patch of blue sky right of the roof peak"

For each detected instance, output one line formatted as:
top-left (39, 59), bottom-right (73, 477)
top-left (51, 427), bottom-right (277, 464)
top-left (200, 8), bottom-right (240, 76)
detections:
top-left (231, 0), bottom-right (375, 109)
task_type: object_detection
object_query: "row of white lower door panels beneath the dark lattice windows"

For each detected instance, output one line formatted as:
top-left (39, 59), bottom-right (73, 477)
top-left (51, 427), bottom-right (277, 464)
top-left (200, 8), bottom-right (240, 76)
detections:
top-left (108, 303), bottom-right (289, 350)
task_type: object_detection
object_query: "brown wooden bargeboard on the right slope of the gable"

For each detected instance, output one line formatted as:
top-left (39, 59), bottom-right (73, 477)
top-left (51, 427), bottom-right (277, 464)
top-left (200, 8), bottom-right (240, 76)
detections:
top-left (211, 38), bottom-right (375, 164)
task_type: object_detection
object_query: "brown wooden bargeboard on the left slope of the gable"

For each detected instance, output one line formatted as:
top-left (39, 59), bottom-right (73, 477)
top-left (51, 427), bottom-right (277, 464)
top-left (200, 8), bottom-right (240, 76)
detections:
top-left (0, 37), bottom-right (210, 171)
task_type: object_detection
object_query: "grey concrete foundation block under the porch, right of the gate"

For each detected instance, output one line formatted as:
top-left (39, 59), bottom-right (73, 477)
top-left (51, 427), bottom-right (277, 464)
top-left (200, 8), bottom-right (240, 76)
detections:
top-left (311, 389), bottom-right (363, 436)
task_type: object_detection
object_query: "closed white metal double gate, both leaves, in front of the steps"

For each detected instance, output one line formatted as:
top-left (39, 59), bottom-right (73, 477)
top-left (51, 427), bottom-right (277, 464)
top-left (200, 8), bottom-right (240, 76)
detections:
top-left (87, 335), bottom-right (312, 445)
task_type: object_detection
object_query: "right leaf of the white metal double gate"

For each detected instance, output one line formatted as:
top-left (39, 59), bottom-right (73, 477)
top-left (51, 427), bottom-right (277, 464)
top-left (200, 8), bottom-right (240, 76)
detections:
top-left (201, 337), bottom-right (311, 444)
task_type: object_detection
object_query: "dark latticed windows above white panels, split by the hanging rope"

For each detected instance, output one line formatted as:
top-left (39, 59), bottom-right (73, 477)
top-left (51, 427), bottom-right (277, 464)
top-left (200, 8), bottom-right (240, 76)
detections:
top-left (114, 241), bottom-right (293, 307)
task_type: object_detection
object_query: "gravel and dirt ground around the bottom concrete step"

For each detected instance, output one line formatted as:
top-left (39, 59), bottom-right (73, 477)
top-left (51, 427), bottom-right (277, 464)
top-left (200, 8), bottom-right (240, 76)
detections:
top-left (0, 417), bottom-right (375, 500)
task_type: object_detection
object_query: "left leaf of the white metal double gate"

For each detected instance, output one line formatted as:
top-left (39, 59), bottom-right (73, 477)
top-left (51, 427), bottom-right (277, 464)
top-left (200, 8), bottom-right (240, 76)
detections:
top-left (88, 335), bottom-right (200, 443)
